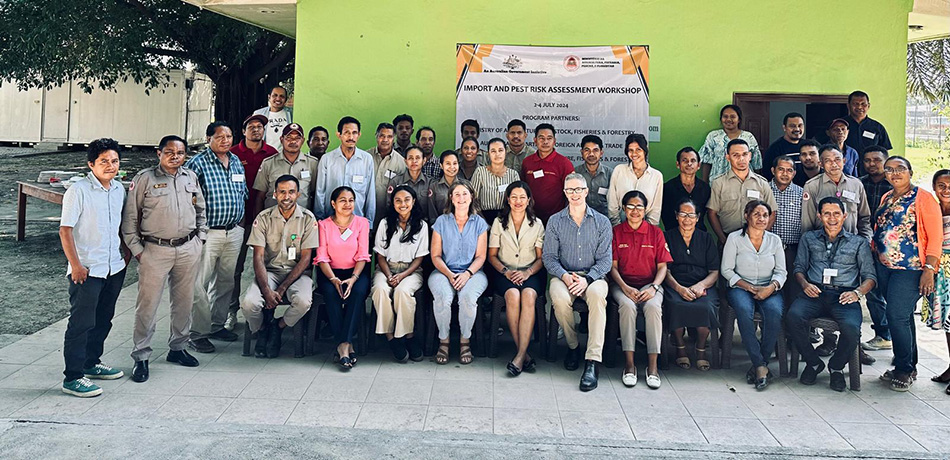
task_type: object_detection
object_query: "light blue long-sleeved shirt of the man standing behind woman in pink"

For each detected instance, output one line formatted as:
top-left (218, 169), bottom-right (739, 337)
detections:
top-left (313, 147), bottom-right (376, 223)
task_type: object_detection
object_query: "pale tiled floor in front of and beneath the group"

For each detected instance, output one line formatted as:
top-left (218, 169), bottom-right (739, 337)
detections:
top-left (0, 287), bottom-right (950, 452)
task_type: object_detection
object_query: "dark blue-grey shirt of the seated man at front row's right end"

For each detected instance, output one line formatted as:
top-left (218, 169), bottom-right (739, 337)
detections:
top-left (795, 229), bottom-right (877, 289)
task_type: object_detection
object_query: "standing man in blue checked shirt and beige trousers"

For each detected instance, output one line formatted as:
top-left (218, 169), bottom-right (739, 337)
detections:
top-left (185, 121), bottom-right (247, 353)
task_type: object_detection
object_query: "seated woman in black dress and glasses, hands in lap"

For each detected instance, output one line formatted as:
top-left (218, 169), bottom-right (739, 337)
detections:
top-left (664, 198), bottom-right (720, 371)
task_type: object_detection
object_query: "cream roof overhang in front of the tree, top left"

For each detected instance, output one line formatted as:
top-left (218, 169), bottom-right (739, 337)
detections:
top-left (182, 0), bottom-right (297, 38)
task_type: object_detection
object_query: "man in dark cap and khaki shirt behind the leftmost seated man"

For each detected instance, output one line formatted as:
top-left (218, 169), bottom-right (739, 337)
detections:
top-left (251, 123), bottom-right (319, 215)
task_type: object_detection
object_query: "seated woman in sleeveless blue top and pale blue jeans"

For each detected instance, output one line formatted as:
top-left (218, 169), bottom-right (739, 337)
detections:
top-left (429, 181), bottom-right (488, 364)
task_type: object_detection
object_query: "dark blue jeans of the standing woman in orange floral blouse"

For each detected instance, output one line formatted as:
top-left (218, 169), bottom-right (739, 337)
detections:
top-left (874, 262), bottom-right (921, 374)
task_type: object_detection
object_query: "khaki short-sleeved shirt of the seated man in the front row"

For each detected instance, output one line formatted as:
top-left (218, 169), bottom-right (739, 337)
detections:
top-left (247, 204), bottom-right (319, 276)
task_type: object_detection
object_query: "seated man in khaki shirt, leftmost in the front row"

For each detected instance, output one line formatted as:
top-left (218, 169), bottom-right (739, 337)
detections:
top-left (241, 175), bottom-right (318, 358)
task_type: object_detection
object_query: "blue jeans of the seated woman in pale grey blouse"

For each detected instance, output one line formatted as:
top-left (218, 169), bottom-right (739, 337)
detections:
top-left (727, 288), bottom-right (784, 366)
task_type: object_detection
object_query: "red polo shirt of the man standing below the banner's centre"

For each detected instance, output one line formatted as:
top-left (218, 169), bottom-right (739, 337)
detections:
top-left (521, 150), bottom-right (574, 223)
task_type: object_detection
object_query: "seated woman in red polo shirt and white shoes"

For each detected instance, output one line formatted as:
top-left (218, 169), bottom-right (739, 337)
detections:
top-left (607, 190), bottom-right (673, 389)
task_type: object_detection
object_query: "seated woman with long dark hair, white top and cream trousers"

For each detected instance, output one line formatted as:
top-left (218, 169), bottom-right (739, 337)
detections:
top-left (370, 184), bottom-right (429, 363)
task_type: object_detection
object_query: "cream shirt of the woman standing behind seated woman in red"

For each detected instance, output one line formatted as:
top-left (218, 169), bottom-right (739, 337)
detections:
top-left (608, 163), bottom-right (663, 225)
